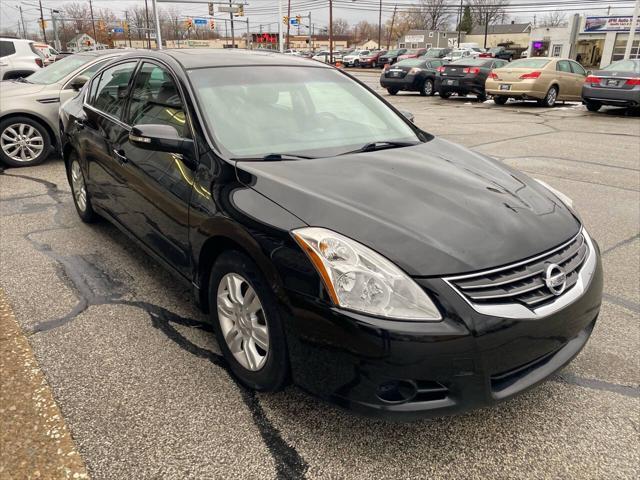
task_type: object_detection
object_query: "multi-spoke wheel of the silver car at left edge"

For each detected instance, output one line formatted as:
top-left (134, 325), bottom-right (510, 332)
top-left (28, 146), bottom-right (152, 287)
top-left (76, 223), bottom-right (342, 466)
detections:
top-left (0, 117), bottom-right (51, 167)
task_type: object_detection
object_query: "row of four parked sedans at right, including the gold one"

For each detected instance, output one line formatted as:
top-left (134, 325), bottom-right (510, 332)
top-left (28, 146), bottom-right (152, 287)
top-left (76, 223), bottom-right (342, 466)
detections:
top-left (380, 57), bottom-right (640, 112)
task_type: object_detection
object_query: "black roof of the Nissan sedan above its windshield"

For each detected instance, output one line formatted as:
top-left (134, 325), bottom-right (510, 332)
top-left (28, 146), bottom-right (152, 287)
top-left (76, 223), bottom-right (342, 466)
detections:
top-left (127, 48), bottom-right (332, 70)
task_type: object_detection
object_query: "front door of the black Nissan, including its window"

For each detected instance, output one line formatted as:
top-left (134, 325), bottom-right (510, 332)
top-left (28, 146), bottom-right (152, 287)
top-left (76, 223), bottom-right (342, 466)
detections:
top-left (115, 61), bottom-right (193, 278)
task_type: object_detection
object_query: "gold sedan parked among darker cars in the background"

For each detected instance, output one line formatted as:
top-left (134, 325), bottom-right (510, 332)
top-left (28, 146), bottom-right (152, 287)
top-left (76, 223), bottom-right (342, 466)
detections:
top-left (485, 57), bottom-right (587, 107)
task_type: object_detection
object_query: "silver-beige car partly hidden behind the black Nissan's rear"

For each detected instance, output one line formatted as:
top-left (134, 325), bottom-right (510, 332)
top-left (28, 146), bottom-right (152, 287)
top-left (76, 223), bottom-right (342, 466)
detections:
top-left (0, 50), bottom-right (124, 167)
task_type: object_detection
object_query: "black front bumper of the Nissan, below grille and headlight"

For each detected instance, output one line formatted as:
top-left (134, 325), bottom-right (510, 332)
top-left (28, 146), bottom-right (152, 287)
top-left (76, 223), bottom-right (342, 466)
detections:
top-left (285, 236), bottom-right (602, 420)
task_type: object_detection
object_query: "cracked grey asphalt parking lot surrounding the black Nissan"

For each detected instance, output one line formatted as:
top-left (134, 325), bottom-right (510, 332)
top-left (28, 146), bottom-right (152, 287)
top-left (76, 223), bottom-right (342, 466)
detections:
top-left (0, 71), bottom-right (640, 479)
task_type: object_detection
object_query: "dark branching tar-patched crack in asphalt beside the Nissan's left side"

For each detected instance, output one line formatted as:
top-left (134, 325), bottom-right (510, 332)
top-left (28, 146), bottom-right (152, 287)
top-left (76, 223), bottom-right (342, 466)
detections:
top-left (6, 174), bottom-right (308, 480)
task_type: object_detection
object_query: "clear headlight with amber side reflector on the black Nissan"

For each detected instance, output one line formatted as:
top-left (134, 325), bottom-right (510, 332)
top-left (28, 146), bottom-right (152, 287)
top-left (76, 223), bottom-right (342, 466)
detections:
top-left (291, 227), bottom-right (442, 320)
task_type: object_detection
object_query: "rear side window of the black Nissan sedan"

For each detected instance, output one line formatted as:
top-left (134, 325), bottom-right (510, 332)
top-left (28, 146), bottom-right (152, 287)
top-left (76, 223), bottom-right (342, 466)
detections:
top-left (89, 62), bottom-right (137, 120)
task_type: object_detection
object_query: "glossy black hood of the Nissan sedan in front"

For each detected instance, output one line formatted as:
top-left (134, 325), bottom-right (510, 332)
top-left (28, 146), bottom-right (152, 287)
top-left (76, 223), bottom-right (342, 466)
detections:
top-left (237, 139), bottom-right (580, 276)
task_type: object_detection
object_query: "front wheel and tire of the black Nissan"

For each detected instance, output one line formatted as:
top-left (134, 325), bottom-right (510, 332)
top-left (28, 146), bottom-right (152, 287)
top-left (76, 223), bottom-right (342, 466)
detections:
top-left (209, 250), bottom-right (289, 392)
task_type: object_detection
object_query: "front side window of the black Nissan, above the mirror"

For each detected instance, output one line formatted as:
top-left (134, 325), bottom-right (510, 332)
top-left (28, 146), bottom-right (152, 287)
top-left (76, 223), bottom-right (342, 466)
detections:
top-left (129, 63), bottom-right (189, 137)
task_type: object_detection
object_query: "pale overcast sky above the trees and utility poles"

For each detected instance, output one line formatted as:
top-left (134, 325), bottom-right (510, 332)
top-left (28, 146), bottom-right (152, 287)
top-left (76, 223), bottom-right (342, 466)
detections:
top-left (0, 0), bottom-right (633, 36)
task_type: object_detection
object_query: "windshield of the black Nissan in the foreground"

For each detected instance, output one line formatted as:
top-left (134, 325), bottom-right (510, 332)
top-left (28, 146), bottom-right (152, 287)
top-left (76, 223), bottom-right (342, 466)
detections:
top-left (189, 66), bottom-right (421, 159)
